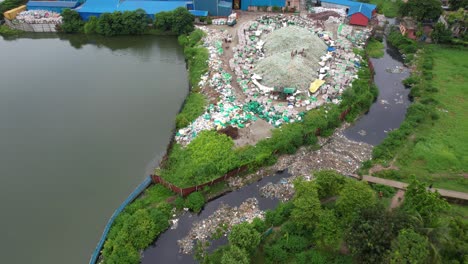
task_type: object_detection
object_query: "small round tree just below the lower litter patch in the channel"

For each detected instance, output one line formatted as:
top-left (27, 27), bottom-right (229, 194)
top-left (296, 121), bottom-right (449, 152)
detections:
top-left (228, 222), bottom-right (261, 252)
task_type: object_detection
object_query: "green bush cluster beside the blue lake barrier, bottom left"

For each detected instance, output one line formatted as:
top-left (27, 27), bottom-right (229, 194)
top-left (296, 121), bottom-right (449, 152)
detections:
top-left (102, 185), bottom-right (173, 264)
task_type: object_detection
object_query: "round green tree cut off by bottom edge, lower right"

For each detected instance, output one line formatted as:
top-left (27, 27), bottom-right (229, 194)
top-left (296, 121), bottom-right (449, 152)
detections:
top-left (390, 229), bottom-right (429, 264)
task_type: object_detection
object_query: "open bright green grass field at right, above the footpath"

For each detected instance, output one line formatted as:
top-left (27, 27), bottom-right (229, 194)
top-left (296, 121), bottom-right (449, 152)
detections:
top-left (397, 46), bottom-right (468, 192)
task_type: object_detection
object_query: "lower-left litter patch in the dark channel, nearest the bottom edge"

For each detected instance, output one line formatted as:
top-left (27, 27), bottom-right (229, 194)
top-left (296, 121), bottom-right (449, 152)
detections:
top-left (177, 198), bottom-right (264, 254)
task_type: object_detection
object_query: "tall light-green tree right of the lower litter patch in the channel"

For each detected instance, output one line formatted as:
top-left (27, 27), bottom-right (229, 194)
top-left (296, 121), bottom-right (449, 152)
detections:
top-left (291, 179), bottom-right (321, 229)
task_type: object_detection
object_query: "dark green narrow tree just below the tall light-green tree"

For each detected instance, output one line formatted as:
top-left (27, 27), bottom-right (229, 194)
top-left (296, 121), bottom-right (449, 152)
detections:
top-left (313, 210), bottom-right (343, 250)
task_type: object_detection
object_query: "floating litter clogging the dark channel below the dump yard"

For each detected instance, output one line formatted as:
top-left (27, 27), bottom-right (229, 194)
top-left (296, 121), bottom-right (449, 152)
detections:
top-left (178, 124), bottom-right (372, 254)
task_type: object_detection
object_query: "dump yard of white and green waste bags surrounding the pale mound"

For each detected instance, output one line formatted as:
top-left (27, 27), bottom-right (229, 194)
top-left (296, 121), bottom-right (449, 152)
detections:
top-left (175, 13), bottom-right (370, 146)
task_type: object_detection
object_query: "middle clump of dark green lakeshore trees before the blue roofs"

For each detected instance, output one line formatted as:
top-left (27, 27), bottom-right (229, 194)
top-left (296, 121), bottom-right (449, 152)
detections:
top-left (96, 9), bottom-right (151, 37)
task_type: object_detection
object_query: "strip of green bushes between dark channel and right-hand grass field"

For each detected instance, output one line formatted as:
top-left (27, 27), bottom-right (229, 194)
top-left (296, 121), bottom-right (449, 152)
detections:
top-left (372, 48), bottom-right (438, 162)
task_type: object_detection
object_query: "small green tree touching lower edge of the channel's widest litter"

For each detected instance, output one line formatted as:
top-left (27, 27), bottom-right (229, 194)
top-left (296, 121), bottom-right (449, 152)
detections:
top-left (314, 170), bottom-right (347, 199)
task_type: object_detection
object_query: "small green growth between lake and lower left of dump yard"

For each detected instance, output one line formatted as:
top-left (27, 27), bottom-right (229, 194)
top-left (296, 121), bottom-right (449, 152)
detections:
top-left (176, 93), bottom-right (206, 129)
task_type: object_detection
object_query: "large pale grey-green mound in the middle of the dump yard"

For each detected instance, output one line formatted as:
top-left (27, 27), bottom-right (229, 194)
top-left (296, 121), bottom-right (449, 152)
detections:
top-left (255, 26), bottom-right (327, 91)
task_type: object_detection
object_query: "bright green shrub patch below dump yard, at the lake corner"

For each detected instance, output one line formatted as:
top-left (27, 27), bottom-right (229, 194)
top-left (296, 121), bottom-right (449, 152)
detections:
top-left (161, 131), bottom-right (238, 187)
